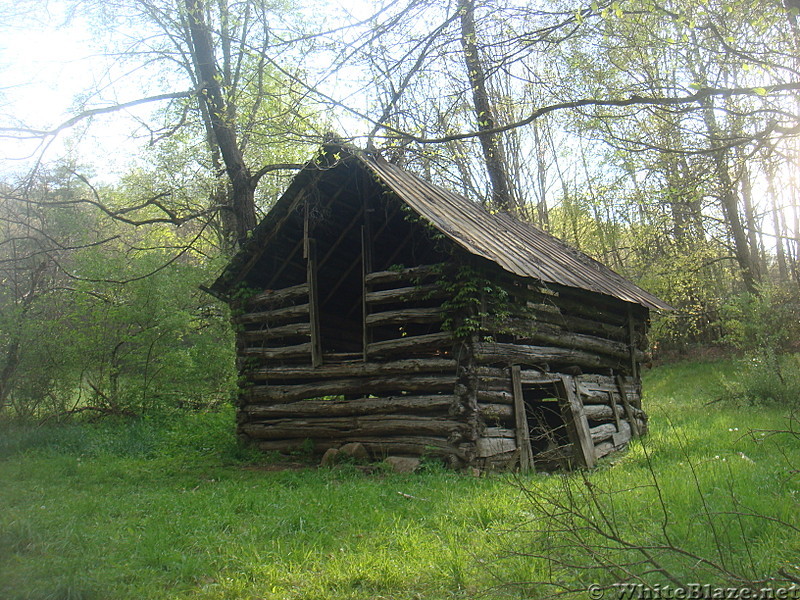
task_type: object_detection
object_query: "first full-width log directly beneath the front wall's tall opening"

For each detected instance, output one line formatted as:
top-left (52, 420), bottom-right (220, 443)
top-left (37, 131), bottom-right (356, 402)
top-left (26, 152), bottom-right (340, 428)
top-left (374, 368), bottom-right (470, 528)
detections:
top-left (248, 355), bottom-right (457, 381)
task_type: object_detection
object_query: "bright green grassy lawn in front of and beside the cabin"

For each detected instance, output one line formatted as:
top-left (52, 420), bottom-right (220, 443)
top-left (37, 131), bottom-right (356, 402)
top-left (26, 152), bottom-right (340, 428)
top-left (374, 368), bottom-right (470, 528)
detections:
top-left (0, 362), bottom-right (800, 600)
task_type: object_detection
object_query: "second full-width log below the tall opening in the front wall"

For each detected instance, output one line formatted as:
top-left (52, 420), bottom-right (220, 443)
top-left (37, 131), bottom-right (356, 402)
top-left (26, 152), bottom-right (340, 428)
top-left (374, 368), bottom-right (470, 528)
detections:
top-left (242, 375), bottom-right (456, 403)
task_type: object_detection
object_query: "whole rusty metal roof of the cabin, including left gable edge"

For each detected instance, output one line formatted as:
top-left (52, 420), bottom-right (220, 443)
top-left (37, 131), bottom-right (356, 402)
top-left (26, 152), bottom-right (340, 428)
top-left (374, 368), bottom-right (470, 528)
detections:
top-left (209, 145), bottom-right (671, 310)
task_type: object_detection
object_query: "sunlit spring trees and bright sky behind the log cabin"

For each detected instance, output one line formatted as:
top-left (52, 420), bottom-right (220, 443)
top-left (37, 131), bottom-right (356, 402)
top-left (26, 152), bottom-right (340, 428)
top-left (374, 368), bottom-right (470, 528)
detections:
top-left (0, 0), bottom-right (800, 420)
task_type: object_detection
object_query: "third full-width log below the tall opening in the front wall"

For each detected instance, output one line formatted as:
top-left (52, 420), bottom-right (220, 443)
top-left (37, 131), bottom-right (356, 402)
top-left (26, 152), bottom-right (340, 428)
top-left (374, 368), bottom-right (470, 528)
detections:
top-left (239, 395), bottom-right (458, 420)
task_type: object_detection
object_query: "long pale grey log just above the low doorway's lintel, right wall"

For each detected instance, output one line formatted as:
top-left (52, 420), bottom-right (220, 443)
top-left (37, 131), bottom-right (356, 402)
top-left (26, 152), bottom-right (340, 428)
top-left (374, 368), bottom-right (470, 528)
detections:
top-left (474, 342), bottom-right (620, 368)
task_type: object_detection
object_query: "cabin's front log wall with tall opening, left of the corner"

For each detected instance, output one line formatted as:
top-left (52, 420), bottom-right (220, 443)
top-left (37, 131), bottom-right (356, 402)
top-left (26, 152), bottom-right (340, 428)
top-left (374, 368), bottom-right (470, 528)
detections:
top-left (234, 266), bottom-right (466, 465)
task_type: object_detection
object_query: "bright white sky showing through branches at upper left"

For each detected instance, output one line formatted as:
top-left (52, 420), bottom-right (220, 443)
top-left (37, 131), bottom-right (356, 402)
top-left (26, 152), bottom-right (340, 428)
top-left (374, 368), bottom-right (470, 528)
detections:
top-left (0, 0), bottom-right (372, 183)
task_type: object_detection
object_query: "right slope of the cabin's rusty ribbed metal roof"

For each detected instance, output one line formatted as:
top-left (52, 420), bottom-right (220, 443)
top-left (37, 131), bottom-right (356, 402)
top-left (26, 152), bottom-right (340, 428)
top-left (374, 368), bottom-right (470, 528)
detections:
top-left (356, 153), bottom-right (671, 310)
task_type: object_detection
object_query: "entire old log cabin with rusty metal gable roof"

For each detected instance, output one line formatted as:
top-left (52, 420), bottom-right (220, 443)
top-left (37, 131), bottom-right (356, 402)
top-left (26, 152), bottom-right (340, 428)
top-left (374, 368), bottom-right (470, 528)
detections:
top-left (209, 143), bottom-right (669, 472)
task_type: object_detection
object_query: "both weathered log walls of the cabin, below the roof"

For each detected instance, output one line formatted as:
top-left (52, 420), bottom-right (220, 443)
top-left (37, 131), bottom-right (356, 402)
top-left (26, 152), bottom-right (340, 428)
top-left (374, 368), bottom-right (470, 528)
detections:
top-left (234, 257), bottom-right (647, 469)
